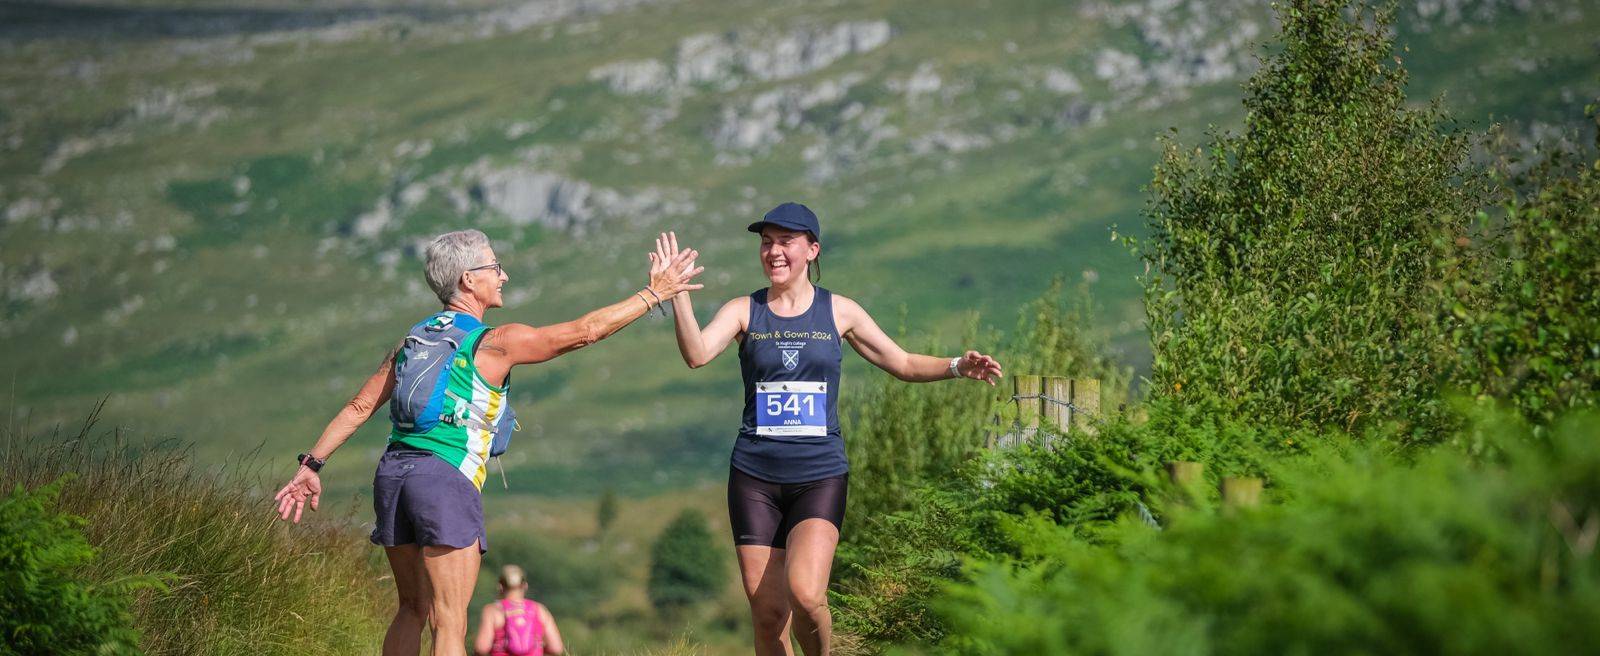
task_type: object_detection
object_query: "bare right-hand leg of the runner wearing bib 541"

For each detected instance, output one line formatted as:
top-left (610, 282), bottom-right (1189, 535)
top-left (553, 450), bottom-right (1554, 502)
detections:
top-left (787, 518), bottom-right (838, 656)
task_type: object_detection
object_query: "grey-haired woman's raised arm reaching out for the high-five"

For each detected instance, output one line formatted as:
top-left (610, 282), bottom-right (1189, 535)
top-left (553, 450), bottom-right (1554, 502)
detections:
top-left (483, 243), bottom-right (706, 365)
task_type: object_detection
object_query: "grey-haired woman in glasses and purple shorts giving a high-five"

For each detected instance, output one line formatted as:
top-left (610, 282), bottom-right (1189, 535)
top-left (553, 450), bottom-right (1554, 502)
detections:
top-left (275, 230), bottom-right (701, 656)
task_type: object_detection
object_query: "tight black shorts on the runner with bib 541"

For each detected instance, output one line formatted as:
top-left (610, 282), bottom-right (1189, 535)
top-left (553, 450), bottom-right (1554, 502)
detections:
top-left (728, 467), bottom-right (850, 549)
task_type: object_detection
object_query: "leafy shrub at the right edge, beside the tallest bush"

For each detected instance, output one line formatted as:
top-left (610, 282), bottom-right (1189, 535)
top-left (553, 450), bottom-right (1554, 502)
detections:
top-left (1440, 146), bottom-right (1600, 422)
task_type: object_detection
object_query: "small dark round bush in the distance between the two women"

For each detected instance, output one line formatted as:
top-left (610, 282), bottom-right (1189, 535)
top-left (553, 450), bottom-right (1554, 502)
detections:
top-left (648, 509), bottom-right (728, 613)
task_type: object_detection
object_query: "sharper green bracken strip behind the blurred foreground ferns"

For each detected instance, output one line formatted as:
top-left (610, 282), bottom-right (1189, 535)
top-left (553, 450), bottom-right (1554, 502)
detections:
top-left (835, 403), bottom-right (1323, 645)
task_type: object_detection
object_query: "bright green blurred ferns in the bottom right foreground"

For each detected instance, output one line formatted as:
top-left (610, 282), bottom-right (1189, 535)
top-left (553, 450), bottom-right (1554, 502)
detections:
top-left (941, 418), bottom-right (1600, 654)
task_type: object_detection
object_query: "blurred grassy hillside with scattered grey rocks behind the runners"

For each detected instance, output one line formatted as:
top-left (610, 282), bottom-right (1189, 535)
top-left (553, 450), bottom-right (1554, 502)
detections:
top-left (0, 0), bottom-right (1600, 494)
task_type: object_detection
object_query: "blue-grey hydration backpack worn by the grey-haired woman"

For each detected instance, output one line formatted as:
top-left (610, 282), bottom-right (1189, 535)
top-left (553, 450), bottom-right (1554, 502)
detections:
top-left (389, 312), bottom-right (517, 456)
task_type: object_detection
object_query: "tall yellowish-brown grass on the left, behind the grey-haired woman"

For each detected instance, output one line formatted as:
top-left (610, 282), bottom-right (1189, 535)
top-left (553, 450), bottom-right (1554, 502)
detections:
top-left (0, 401), bottom-right (394, 654)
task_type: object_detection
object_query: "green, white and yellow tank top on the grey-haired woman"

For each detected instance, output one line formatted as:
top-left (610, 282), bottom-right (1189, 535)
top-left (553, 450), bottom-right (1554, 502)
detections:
top-left (389, 326), bottom-right (510, 490)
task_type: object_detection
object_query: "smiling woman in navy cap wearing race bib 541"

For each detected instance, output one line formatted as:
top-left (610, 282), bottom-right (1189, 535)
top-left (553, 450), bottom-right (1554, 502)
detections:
top-left (650, 203), bottom-right (1000, 656)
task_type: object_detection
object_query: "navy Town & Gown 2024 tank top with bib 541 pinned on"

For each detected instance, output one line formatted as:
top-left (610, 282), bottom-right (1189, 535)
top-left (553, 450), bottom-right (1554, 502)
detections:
top-left (733, 286), bottom-right (850, 483)
